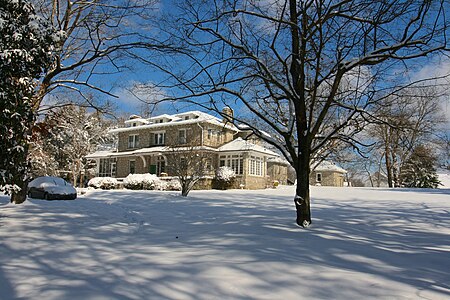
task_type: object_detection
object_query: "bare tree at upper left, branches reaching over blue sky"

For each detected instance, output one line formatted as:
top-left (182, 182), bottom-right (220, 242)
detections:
top-left (33, 0), bottom-right (169, 110)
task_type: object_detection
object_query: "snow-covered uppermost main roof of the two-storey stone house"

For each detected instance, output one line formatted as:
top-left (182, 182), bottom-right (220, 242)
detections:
top-left (109, 111), bottom-right (239, 133)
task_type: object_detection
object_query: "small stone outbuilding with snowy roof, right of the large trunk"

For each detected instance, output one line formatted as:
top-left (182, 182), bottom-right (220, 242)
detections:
top-left (309, 161), bottom-right (347, 187)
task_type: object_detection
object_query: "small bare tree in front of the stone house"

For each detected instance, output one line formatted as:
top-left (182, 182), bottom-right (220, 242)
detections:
top-left (167, 140), bottom-right (213, 197)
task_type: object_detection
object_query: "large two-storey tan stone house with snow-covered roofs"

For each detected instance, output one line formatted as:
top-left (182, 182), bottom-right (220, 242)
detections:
top-left (86, 107), bottom-right (287, 189)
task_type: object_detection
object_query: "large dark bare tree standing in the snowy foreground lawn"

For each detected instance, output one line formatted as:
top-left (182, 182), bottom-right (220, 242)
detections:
top-left (148, 0), bottom-right (450, 226)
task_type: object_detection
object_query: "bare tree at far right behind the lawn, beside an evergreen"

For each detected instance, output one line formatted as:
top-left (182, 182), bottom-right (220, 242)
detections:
top-left (369, 87), bottom-right (445, 187)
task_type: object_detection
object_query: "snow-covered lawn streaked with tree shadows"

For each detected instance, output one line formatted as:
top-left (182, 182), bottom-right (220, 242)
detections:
top-left (0, 187), bottom-right (450, 300)
